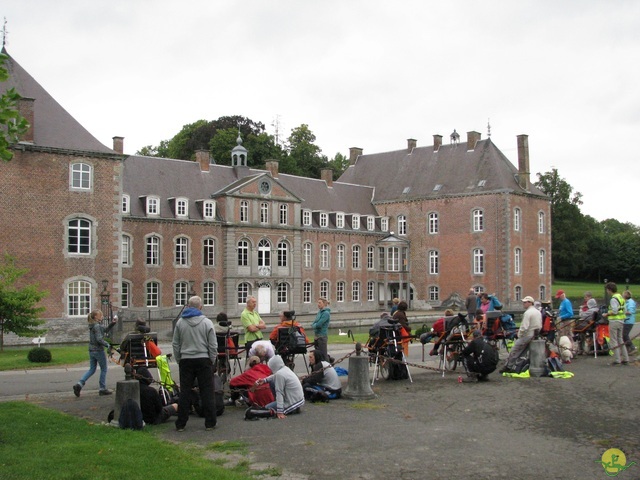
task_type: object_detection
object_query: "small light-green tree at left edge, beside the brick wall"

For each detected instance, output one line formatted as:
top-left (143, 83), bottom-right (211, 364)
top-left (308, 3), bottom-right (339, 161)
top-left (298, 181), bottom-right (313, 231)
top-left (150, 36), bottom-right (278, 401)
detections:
top-left (0, 254), bottom-right (48, 351)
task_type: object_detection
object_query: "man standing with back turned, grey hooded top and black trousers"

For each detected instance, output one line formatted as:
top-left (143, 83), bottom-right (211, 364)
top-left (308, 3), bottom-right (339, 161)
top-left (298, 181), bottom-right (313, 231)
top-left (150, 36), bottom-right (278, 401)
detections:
top-left (172, 296), bottom-right (218, 432)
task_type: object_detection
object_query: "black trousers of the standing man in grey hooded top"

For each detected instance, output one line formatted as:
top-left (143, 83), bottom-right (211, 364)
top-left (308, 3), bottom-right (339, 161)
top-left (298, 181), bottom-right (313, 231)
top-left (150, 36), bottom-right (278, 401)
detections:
top-left (176, 357), bottom-right (217, 428)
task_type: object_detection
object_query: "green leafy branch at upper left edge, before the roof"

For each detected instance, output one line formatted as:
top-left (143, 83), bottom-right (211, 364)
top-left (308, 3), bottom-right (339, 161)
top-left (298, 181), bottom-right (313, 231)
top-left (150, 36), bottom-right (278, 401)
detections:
top-left (0, 53), bottom-right (29, 162)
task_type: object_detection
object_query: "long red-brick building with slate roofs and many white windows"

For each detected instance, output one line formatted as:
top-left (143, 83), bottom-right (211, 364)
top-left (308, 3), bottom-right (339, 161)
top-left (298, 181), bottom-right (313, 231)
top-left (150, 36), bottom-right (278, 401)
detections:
top-left (0, 52), bottom-right (551, 343)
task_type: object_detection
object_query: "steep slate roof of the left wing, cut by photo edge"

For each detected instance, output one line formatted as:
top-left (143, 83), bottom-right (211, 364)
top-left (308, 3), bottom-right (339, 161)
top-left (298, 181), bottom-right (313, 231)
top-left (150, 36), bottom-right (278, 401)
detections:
top-left (0, 48), bottom-right (115, 154)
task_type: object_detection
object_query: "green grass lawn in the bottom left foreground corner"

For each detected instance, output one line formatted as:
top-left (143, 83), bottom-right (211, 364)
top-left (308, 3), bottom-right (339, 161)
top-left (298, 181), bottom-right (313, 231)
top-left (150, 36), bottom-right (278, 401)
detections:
top-left (0, 402), bottom-right (255, 480)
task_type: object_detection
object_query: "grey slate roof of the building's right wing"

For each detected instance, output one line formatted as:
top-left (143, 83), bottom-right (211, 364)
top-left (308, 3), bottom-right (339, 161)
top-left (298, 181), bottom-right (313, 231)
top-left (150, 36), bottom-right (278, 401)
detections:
top-left (339, 139), bottom-right (544, 202)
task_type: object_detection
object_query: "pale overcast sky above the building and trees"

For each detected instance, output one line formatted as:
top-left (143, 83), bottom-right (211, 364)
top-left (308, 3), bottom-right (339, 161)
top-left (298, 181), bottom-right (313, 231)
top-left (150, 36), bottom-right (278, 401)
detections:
top-left (0, 0), bottom-right (640, 224)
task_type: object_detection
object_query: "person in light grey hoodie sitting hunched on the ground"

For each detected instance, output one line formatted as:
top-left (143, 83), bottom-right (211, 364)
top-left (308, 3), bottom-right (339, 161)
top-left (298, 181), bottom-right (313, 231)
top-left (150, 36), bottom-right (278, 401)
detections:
top-left (255, 355), bottom-right (304, 420)
